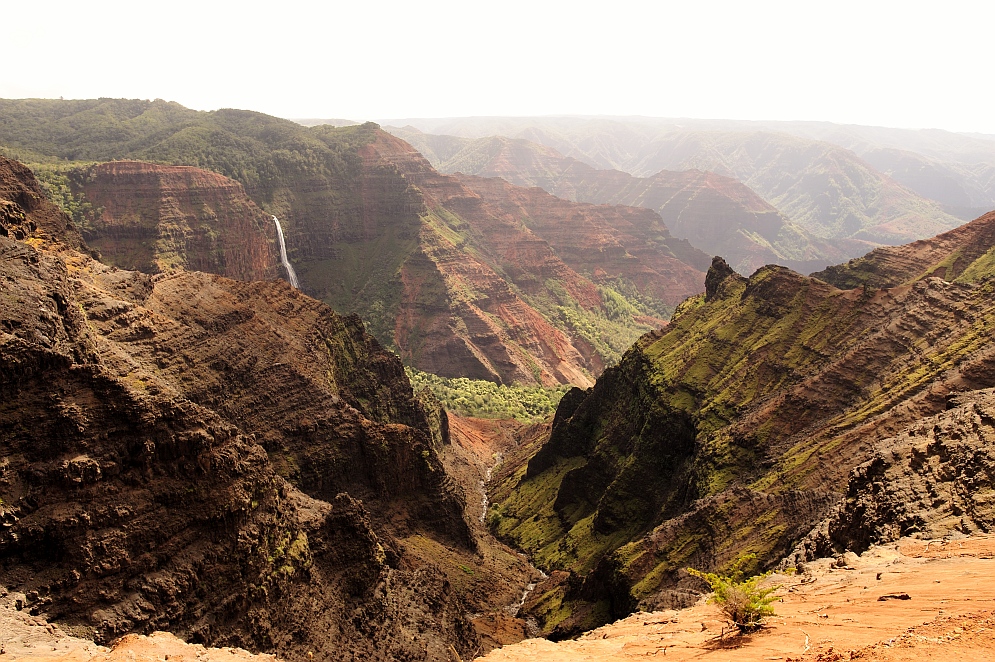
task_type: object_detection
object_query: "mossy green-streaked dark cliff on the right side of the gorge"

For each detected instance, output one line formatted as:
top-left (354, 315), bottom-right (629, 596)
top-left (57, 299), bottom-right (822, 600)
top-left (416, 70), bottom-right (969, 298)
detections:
top-left (490, 223), bottom-right (995, 633)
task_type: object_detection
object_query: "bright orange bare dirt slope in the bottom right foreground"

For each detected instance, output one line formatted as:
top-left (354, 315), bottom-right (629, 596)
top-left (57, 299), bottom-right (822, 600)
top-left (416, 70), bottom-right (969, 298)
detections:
top-left (482, 535), bottom-right (995, 662)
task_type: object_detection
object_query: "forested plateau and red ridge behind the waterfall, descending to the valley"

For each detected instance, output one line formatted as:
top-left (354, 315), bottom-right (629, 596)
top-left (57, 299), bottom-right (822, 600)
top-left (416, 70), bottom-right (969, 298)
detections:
top-left (0, 100), bottom-right (716, 385)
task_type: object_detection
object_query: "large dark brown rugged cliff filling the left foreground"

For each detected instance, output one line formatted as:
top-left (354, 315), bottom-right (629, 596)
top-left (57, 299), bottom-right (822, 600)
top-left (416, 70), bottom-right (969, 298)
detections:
top-left (0, 160), bottom-right (477, 660)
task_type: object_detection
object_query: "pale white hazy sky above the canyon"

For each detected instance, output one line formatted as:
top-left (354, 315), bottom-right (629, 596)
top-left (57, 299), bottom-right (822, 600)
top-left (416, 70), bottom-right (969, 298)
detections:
top-left (7, 0), bottom-right (995, 134)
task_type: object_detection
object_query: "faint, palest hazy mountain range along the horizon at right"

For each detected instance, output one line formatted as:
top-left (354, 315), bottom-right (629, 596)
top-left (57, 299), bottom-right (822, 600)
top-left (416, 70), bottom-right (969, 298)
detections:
top-left (380, 117), bottom-right (995, 257)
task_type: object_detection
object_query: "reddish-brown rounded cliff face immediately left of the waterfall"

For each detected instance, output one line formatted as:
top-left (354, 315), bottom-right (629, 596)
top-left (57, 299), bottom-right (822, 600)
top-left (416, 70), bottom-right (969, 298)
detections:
top-left (80, 161), bottom-right (282, 280)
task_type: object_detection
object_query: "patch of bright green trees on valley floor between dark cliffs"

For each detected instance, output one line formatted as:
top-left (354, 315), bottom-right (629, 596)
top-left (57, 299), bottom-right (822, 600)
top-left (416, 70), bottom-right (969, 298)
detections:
top-left (405, 367), bottom-right (570, 422)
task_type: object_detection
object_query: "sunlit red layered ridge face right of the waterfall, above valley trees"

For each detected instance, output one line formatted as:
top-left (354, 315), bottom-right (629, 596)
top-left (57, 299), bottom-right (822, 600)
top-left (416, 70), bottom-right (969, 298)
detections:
top-left (361, 132), bottom-right (705, 385)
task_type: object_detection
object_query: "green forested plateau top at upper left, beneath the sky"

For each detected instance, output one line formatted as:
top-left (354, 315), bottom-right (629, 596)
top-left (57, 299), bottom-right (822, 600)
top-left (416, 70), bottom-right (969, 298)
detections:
top-left (0, 99), bottom-right (377, 190)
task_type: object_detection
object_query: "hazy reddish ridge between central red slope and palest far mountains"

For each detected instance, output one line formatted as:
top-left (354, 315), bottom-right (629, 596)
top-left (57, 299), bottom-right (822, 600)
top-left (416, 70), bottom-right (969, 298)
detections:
top-left (397, 130), bottom-right (848, 275)
